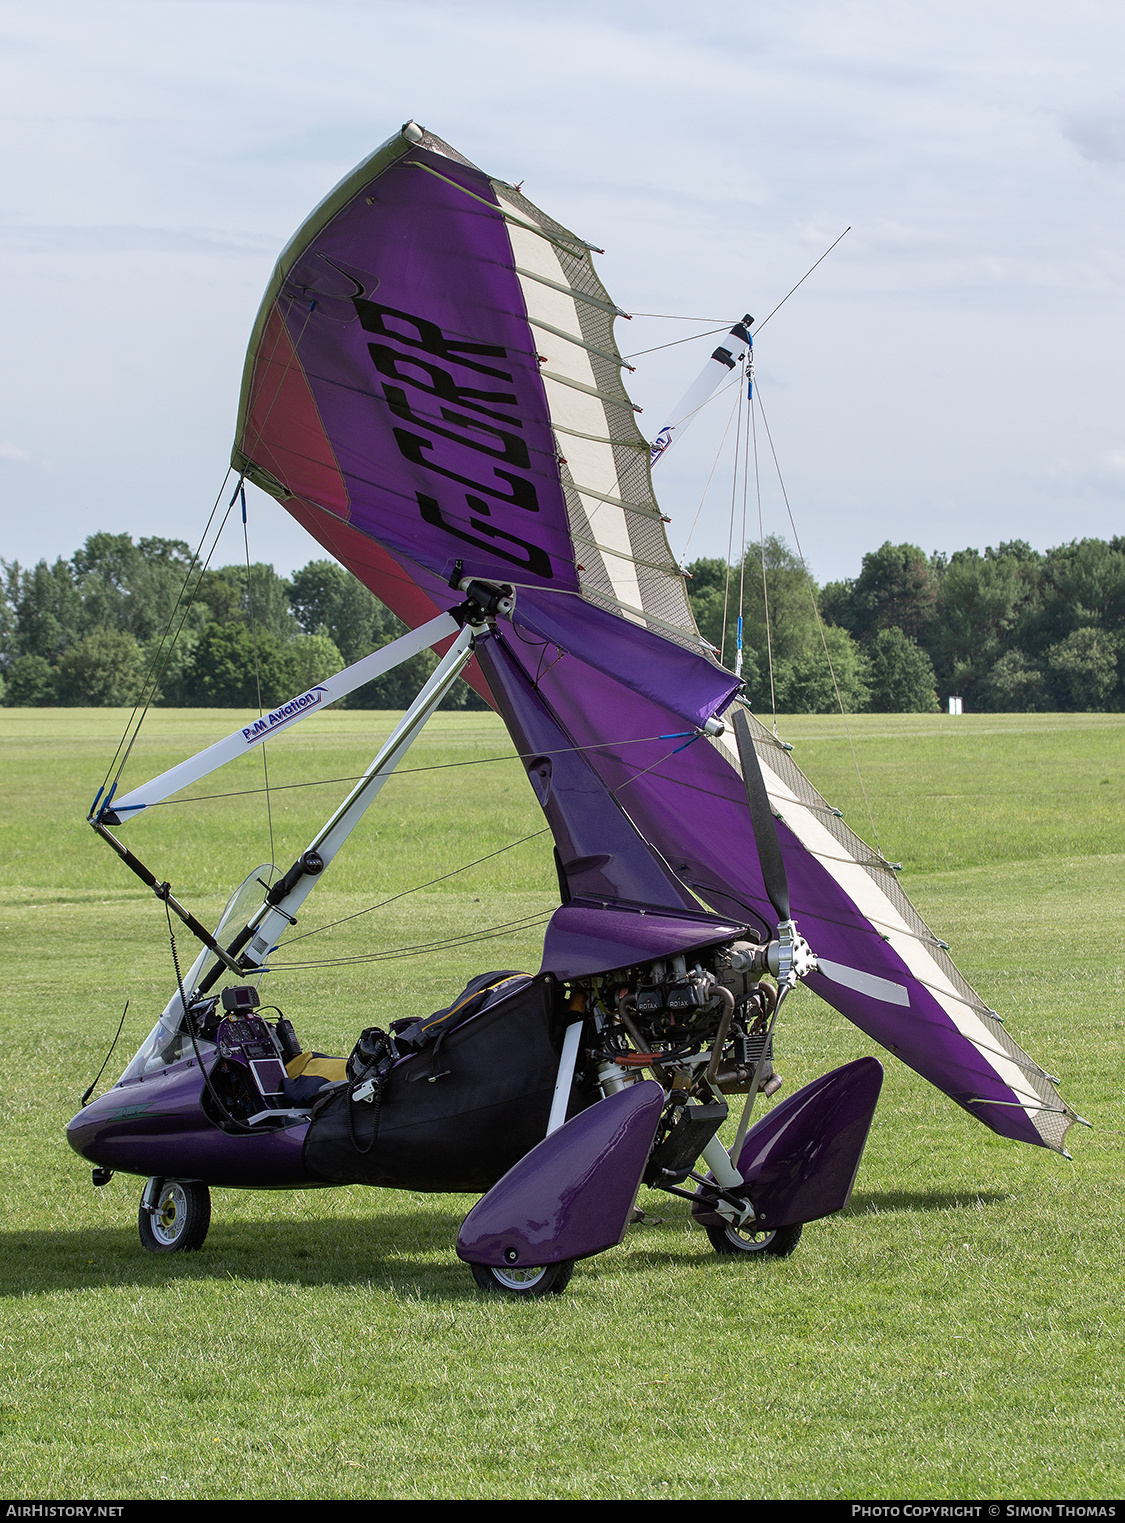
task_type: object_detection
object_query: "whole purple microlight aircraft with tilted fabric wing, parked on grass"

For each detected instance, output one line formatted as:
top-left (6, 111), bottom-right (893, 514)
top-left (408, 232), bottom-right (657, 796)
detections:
top-left (69, 122), bottom-right (1076, 1296)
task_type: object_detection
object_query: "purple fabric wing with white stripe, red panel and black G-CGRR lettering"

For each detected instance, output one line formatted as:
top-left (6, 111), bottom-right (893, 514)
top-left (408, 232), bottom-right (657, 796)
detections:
top-left (233, 123), bottom-right (1073, 1148)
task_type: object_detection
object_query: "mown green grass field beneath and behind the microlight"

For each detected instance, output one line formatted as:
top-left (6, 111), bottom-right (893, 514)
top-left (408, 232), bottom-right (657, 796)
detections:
top-left (0, 710), bottom-right (1125, 1499)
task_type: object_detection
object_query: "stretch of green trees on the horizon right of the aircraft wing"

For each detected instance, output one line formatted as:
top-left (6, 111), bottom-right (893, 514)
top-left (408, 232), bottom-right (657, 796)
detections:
top-left (687, 536), bottom-right (1125, 714)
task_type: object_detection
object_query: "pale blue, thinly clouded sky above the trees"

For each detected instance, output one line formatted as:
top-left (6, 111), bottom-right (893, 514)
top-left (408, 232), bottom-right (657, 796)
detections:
top-left (0, 0), bottom-right (1125, 582)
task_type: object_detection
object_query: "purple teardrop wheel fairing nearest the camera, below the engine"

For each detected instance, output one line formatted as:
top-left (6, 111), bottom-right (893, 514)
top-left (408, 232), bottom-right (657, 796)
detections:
top-left (457, 1078), bottom-right (664, 1269)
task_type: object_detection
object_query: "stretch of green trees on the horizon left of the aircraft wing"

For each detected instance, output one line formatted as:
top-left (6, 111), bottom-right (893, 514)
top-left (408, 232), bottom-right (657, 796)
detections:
top-left (0, 535), bottom-right (486, 708)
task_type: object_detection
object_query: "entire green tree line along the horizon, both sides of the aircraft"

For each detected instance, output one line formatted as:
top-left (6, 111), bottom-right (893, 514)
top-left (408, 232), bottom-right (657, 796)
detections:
top-left (0, 533), bottom-right (1125, 713)
